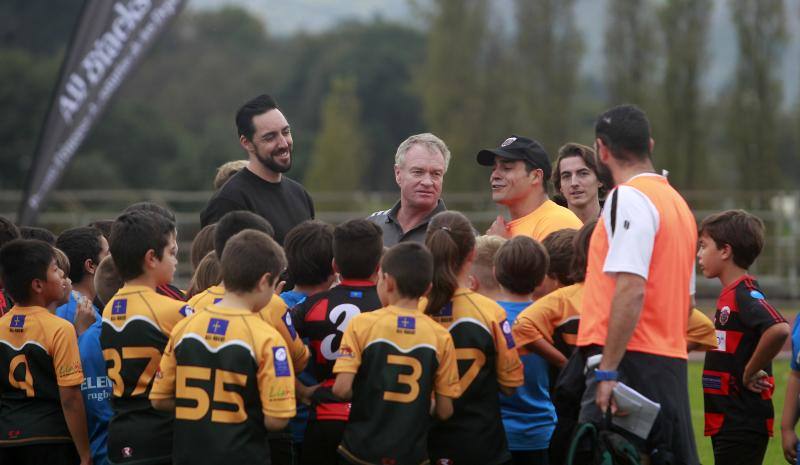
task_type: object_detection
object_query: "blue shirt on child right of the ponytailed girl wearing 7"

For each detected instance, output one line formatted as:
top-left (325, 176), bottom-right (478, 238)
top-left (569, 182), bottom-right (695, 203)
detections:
top-left (497, 301), bottom-right (556, 451)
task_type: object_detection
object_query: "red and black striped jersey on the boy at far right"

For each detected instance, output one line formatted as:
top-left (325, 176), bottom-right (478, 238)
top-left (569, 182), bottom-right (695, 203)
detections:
top-left (703, 275), bottom-right (786, 436)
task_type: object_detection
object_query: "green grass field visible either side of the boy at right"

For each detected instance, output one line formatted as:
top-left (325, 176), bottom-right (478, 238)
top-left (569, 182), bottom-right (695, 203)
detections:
top-left (689, 360), bottom-right (789, 465)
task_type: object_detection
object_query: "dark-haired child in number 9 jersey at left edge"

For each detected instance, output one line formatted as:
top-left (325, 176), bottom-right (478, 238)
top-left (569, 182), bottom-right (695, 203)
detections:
top-left (0, 239), bottom-right (91, 465)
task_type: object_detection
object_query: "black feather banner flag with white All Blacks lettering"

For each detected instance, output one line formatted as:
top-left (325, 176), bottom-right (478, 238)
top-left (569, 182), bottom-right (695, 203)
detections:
top-left (18, 0), bottom-right (186, 224)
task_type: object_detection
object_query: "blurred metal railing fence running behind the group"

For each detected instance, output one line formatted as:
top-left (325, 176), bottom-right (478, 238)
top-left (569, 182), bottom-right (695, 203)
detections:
top-left (0, 189), bottom-right (800, 300)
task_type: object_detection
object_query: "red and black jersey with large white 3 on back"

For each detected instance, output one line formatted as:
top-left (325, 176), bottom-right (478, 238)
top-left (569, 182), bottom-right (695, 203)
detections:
top-left (292, 280), bottom-right (381, 421)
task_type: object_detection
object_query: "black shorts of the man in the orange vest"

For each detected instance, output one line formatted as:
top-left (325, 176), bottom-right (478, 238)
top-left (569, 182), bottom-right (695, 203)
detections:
top-left (579, 346), bottom-right (700, 465)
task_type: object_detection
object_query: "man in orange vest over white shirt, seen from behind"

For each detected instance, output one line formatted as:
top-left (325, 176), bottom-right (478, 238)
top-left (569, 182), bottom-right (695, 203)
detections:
top-left (577, 105), bottom-right (698, 465)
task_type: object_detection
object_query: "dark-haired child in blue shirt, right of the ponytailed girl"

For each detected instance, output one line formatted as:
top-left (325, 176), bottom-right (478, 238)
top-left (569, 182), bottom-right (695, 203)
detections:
top-left (494, 237), bottom-right (552, 465)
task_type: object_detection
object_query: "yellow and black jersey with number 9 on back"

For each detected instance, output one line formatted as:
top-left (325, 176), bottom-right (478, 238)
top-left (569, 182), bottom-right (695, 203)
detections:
top-left (0, 306), bottom-right (83, 447)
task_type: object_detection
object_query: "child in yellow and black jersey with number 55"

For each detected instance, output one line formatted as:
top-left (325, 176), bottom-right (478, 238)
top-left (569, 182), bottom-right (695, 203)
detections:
top-left (150, 230), bottom-right (295, 465)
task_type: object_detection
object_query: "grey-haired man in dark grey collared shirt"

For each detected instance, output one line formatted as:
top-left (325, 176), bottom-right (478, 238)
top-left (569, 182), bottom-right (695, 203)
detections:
top-left (367, 133), bottom-right (450, 247)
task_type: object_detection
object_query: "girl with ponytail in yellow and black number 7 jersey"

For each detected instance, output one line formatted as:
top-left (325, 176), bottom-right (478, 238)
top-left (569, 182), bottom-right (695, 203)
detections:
top-left (425, 211), bottom-right (532, 463)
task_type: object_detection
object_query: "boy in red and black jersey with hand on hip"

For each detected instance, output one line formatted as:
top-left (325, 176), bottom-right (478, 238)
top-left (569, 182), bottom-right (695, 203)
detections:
top-left (697, 210), bottom-right (790, 464)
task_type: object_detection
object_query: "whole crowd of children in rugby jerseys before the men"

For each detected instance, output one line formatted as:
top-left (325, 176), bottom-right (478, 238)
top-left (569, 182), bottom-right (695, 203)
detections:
top-left (0, 169), bottom-right (800, 465)
